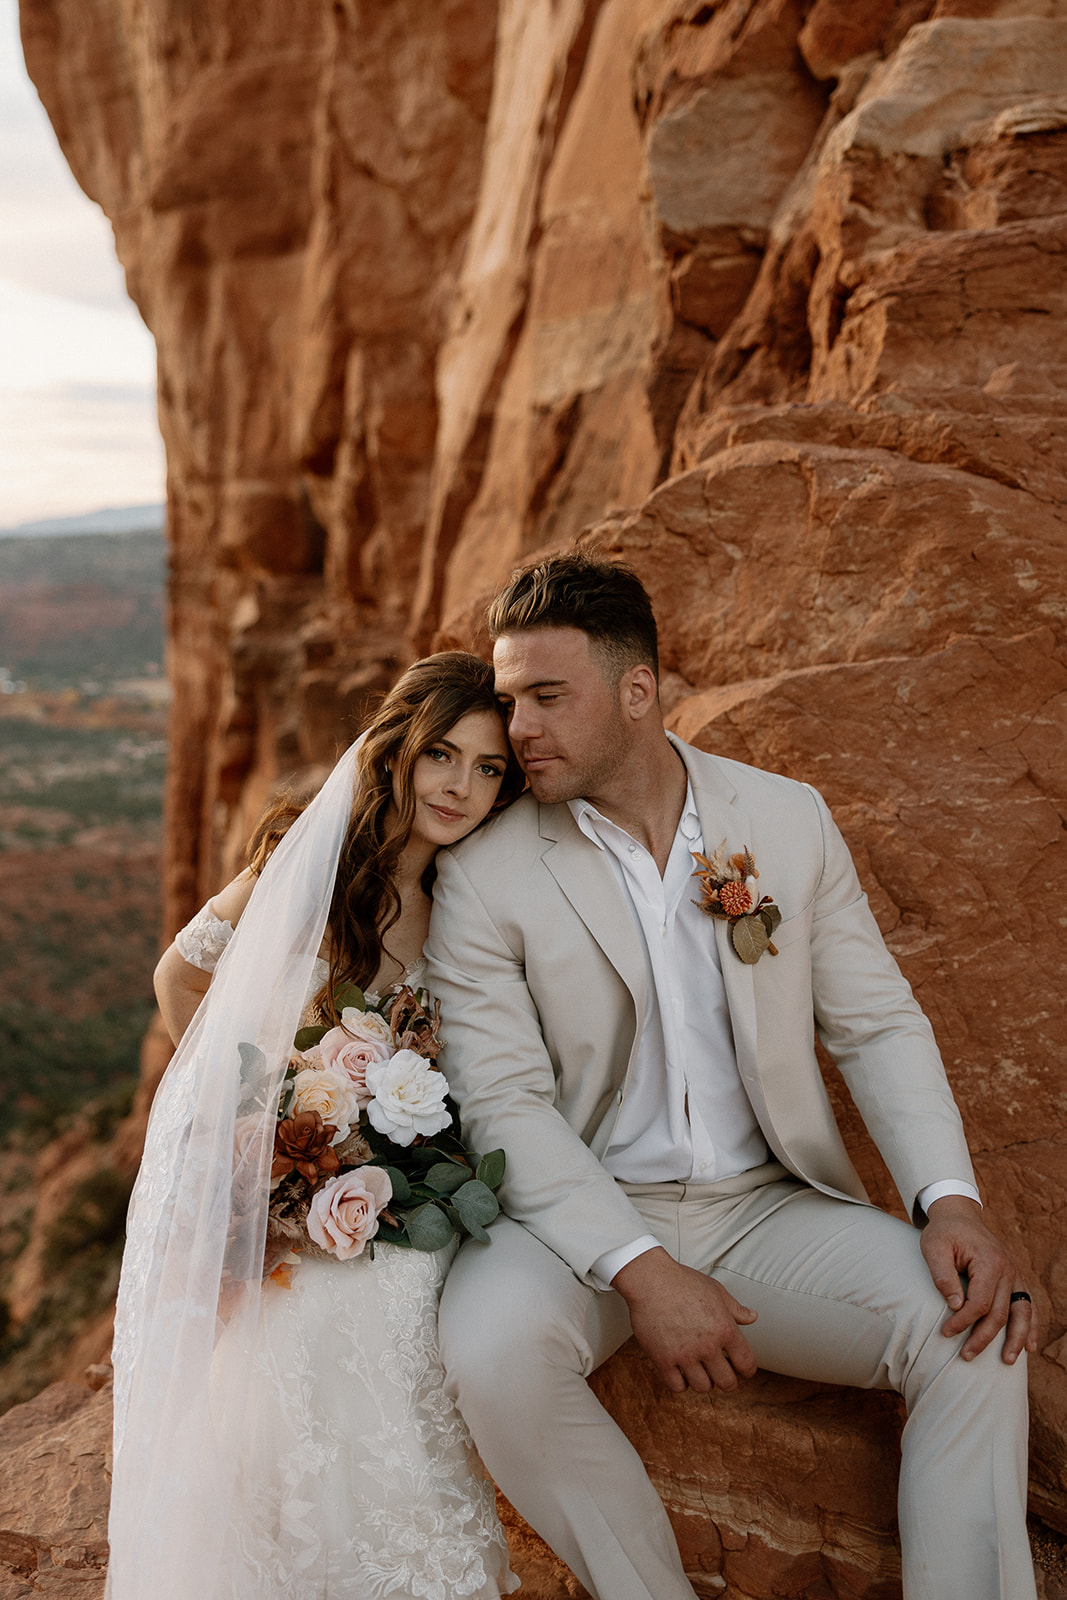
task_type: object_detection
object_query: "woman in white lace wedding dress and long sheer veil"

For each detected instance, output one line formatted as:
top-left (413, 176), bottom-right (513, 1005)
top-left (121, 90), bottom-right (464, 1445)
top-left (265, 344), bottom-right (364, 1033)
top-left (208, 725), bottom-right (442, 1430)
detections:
top-left (107, 651), bottom-right (522, 1600)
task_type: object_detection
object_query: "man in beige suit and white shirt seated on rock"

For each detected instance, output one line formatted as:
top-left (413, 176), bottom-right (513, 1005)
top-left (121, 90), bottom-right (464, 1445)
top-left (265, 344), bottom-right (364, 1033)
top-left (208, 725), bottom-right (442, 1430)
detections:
top-left (427, 554), bottom-right (1035, 1600)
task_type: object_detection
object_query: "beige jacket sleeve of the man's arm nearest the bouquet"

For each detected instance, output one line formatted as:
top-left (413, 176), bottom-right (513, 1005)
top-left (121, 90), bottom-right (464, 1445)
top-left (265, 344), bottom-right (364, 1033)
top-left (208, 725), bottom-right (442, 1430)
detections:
top-left (426, 851), bottom-right (648, 1288)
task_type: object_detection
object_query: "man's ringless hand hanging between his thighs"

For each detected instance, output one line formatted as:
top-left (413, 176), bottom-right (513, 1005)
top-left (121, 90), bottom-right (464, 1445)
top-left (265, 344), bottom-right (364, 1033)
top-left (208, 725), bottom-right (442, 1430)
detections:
top-left (611, 1250), bottom-right (757, 1394)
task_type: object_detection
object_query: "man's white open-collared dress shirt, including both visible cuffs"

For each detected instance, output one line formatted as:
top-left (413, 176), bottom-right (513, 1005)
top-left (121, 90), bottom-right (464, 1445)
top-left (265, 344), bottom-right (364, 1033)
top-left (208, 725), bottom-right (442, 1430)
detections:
top-left (568, 786), bottom-right (977, 1288)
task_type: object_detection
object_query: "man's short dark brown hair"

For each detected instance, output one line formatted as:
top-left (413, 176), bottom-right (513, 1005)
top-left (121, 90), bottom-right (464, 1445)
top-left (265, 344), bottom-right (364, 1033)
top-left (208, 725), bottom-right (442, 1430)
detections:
top-left (485, 550), bottom-right (659, 682)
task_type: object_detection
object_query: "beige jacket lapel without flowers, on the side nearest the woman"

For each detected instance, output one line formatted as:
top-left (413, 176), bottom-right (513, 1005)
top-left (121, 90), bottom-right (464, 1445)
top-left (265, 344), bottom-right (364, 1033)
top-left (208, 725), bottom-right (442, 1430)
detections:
top-left (541, 805), bottom-right (648, 1034)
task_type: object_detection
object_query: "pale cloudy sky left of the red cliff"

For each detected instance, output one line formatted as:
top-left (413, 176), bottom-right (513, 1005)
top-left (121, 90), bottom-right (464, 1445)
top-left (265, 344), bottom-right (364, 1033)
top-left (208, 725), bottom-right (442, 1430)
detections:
top-left (0, 0), bottom-right (163, 528)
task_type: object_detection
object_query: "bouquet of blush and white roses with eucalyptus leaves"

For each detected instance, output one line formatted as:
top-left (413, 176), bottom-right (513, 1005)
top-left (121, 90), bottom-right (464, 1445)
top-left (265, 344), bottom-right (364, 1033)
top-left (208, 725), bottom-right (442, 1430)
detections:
top-left (252, 984), bottom-right (504, 1275)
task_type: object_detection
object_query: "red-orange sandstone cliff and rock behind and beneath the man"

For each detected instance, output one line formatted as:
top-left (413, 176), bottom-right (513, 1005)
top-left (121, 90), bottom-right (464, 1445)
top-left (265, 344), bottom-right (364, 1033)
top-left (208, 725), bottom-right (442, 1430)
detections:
top-left (22, 0), bottom-right (1067, 1600)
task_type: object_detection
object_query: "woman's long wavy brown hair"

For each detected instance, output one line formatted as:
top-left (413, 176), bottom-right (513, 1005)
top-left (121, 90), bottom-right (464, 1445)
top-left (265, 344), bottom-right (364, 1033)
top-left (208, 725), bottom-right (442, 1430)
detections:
top-left (248, 650), bottom-right (525, 1022)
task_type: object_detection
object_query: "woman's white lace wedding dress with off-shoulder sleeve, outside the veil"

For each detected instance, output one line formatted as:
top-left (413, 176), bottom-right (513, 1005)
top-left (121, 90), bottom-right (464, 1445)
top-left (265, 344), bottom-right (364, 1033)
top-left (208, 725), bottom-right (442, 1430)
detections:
top-left (179, 912), bottom-right (518, 1600)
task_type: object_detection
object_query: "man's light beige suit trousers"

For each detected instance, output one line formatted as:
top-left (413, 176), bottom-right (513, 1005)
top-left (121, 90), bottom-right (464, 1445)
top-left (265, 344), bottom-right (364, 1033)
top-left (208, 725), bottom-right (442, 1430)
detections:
top-left (440, 1163), bottom-right (1035, 1600)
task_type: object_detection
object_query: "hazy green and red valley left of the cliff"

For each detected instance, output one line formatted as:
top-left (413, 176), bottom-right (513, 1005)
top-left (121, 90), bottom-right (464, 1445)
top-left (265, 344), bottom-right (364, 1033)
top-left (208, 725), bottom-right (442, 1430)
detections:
top-left (0, 528), bottom-right (166, 1411)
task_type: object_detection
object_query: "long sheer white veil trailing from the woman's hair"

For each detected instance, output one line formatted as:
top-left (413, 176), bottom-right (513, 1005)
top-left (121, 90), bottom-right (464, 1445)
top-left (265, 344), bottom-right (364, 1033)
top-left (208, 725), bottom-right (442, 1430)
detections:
top-left (107, 742), bottom-right (358, 1600)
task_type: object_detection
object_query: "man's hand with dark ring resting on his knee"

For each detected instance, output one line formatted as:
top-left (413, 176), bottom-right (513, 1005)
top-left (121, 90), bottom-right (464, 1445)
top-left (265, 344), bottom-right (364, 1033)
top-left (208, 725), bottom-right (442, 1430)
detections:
top-left (921, 1195), bottom-right (1037, 1365)
